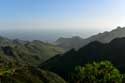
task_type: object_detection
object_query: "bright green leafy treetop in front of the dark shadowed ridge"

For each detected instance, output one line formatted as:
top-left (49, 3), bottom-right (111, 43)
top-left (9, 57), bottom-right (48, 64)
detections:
top-left (70, 61), bottom-right (123, 83)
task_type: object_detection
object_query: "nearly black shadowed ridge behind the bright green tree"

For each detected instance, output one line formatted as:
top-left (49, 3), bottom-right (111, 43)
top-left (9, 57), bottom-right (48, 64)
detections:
top-left (40, 37), bottom-right (125, 79)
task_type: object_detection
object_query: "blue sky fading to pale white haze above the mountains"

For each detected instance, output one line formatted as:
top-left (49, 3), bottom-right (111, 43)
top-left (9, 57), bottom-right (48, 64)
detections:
top-left (0, 0), bottom-right (125, 40)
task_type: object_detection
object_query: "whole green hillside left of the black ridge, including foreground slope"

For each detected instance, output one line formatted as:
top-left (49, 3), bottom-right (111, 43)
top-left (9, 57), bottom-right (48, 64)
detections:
top-left (0, 37), bottom-right (66, 83)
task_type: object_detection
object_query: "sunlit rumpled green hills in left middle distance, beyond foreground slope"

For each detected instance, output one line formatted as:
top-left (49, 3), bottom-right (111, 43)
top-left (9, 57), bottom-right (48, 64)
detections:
top-left (0, 37), bottom-right (64, 65)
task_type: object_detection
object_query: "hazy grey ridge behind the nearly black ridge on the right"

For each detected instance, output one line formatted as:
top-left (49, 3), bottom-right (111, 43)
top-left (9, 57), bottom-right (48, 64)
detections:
top-left (55, 27), bottom-right (125, 50)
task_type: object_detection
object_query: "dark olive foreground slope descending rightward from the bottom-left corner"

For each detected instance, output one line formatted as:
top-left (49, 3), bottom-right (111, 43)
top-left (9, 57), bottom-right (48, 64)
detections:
top-left (0, 62), bottom-right (66, 83)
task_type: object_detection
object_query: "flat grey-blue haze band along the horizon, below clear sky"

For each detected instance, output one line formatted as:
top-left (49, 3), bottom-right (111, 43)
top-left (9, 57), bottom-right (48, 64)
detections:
top-left (0, 29), bottom-right (111, 42)
